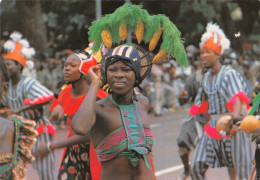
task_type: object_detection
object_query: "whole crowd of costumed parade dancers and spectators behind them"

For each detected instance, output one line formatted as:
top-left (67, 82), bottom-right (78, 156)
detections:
top-left (0, 4), bottom-right (260, 180)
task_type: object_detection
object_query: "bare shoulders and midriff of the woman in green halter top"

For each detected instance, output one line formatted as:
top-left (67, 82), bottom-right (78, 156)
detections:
top-left (91, 96), bottom-right (153, 180)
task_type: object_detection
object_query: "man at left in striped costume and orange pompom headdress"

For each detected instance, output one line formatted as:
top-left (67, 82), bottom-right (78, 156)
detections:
top-left (2, 32), bottom-right (55, 180)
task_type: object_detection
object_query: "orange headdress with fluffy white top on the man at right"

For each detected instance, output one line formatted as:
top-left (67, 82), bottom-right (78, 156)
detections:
top-left (200, 22), bottom-right (230, 55)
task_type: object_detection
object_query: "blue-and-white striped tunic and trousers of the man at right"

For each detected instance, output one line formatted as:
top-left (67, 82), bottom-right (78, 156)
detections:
top-left (191, 66), bottom-right (252, 179)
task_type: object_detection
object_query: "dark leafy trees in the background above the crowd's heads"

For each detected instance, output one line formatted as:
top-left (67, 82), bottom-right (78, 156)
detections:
top-left (0, 0), bottom-right (260, 60)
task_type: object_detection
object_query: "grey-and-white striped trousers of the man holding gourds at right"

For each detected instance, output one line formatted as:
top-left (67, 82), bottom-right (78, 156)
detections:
top-left (190, 114), bottom-right (252, 180)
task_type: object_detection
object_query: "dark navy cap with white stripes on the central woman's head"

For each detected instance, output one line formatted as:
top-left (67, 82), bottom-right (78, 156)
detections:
top-left (105, 45), bottom-right (141, 86)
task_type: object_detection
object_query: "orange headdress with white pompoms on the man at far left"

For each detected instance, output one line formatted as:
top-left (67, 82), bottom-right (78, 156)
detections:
top-left (3, 32), bottom-right (35, 67)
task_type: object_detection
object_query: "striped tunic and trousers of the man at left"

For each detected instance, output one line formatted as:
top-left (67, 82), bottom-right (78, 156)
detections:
top-left (2, 76), bottom-right (54, 180)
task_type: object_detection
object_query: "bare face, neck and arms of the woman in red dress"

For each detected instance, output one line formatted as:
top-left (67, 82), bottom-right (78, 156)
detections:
top-left (36, 55), bottom-right (89, 156)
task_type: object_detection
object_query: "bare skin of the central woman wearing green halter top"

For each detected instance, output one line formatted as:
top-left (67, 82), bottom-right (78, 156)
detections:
top-left (72, 61), bottom-right (153, 180)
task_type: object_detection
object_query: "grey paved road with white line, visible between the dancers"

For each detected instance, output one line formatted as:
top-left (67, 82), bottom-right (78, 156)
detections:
top-left (27, 110), bottom-right (234, 180)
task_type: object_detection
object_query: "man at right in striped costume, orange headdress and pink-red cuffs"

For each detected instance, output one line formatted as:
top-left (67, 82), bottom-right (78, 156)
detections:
top-left (189, 22), bottom-right (252, 180)
